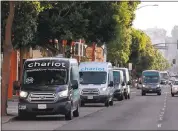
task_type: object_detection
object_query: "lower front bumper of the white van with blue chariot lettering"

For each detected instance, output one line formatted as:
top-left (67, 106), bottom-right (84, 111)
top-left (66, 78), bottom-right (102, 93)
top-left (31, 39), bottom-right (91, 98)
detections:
top-left (80, 95), bottom-right (109, 103)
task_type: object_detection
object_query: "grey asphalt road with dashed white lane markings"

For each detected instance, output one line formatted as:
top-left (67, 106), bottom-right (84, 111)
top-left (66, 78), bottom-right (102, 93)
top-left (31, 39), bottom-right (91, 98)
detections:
top-left (2, 87), bottom-right (178, 131)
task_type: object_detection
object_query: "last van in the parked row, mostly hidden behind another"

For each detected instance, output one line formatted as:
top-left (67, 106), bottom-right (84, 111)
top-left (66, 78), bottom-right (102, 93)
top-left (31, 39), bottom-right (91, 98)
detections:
top-left (115, 68), bottom-right (131, 99)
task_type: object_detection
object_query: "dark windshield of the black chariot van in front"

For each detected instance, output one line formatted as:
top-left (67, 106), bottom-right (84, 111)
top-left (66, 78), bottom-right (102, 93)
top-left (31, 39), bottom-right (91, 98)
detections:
top-left (23, 68), bottom-right (68, 85)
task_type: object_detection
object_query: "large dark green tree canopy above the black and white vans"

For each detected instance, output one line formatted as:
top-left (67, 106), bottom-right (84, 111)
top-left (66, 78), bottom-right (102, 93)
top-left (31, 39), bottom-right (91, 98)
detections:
top-left (35, 1), bottom-right (116, 44)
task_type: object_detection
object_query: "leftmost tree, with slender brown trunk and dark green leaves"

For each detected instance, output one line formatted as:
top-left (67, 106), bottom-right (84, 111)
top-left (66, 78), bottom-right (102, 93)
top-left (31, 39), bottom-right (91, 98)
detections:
top-left (1, 1), bottom-right (50, 115)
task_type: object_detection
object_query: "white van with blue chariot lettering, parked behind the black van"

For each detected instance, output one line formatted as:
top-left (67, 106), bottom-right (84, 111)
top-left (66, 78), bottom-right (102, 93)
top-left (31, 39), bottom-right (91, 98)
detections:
top-left (79, 62), bottom-right (114, 107)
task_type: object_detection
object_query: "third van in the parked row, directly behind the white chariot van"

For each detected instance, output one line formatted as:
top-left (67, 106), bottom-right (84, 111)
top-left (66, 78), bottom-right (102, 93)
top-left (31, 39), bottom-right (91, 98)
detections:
top-left (113, 70), bottom-right (125, 101)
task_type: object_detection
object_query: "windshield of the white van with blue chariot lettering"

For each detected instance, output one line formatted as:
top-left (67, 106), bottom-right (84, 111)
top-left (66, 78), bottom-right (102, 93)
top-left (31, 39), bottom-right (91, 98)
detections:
top-left (79, 72), bottom-right (107, 84)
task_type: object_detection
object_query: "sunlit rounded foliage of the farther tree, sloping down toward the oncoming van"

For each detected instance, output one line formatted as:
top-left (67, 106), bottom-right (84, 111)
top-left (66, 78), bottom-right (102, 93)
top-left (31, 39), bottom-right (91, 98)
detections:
top-left (130, 29), bottom-right (169, 77)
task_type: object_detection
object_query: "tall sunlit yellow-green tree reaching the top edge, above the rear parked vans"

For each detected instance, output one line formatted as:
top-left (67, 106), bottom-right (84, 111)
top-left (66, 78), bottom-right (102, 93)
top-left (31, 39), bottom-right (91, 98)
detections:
top-left (108, 1), bottom-right (140, 66)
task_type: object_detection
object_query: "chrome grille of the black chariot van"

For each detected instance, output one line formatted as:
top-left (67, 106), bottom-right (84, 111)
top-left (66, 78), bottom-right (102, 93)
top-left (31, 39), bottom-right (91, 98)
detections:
top-left (28, 93), bottom-right (57, 103)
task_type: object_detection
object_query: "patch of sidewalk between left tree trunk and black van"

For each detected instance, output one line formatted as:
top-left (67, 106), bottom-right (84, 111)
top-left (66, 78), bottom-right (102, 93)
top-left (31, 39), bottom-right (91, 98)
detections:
top-left (1, 99), bottom-right (18, 124)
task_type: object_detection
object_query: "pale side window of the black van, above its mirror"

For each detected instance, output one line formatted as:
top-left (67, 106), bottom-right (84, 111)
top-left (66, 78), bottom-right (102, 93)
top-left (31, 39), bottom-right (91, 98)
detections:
top-left (70, 66), bottom-right (79, 81)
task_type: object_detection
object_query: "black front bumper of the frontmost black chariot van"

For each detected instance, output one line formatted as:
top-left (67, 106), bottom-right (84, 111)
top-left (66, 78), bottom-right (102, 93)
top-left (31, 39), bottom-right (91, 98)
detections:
top-left (18, 101), bottom-right (71, 115)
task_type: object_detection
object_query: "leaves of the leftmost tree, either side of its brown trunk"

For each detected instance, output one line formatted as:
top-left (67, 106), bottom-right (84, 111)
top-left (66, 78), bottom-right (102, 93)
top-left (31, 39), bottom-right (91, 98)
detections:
top-left (1, 1), bottom-right (52, 49)
